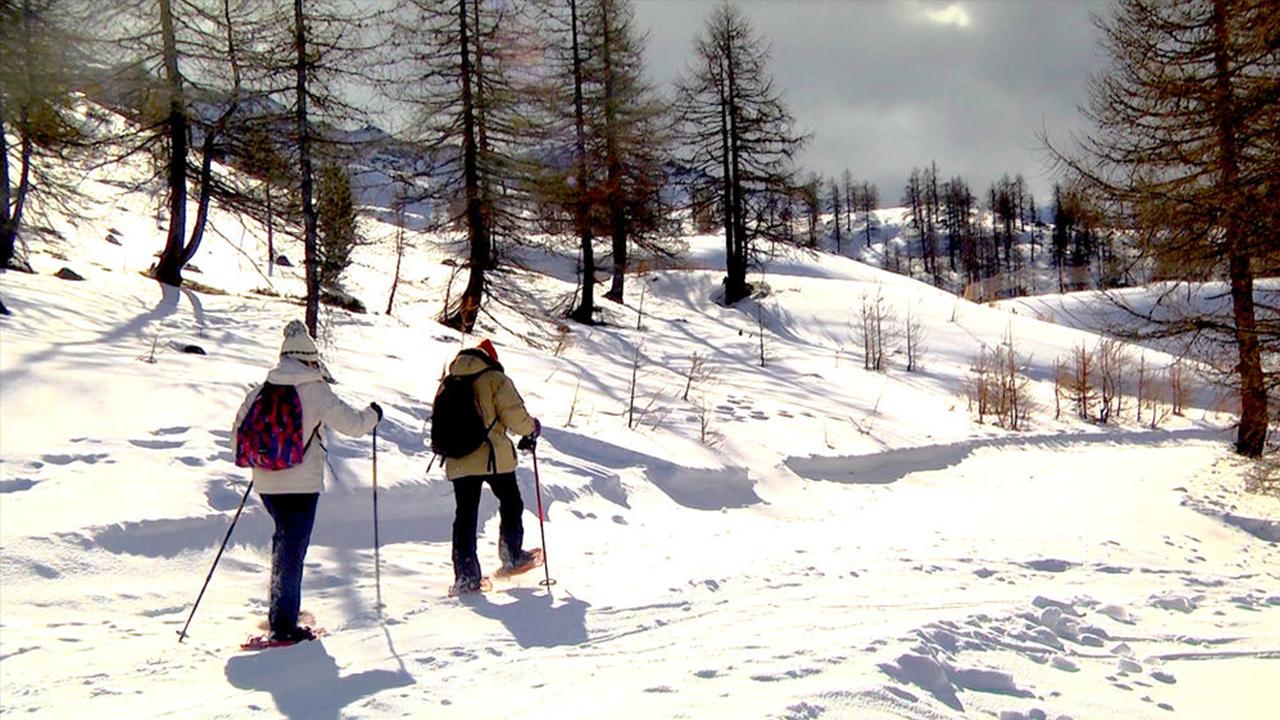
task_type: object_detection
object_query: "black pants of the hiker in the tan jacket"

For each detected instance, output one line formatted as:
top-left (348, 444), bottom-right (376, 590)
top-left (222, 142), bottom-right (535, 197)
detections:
top-left (453, 473), bottom-right (525, 582)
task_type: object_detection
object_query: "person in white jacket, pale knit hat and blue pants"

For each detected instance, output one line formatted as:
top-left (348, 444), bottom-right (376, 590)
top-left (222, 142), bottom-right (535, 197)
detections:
top-left (232, 320), bottom-right (383, 642)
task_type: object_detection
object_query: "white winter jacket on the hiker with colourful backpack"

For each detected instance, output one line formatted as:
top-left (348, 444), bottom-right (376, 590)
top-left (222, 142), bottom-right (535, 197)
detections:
top-left (232, 357), bottom-right (378, 495)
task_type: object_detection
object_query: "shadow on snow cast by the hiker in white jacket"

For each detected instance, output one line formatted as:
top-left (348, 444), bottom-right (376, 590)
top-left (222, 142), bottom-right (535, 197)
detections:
top-left (225, 639), bottom-right (413, 720)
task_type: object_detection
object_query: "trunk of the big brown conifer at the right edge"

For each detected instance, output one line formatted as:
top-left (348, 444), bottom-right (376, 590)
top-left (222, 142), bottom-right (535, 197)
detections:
top-left (1213, 0), bottom-right (1267, 457)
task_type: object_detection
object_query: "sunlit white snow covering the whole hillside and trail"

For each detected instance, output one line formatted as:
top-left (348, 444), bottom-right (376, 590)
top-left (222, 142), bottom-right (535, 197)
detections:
top-left (0, 154), bottom-right (1280, 719)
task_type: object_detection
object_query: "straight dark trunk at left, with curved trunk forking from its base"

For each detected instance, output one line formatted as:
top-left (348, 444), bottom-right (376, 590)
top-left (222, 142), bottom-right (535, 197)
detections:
top-left (155, 0), bottom-right (187, 287)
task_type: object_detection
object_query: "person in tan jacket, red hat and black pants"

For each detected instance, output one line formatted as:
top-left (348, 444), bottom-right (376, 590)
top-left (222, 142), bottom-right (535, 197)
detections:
top-left (433, 340), bottom-right (541, 594)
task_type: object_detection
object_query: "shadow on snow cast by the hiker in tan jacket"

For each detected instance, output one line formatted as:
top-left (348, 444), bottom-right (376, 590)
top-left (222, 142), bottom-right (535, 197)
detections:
top-left (462, 588), bottom-right (591, 648)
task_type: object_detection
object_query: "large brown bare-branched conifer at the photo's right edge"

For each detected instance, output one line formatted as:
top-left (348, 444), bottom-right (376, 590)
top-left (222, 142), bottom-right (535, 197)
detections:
top-left (1062, 0), bottom-right (1280, 457)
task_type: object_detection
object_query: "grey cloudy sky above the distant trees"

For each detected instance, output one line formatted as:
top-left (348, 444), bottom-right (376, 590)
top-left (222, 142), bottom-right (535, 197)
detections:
top-left (636, 0), bottom-right (1107, 205)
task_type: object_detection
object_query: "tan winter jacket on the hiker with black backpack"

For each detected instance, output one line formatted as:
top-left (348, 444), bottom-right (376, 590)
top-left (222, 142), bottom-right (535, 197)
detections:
top-left (444, 354), bottom-right (534, 480)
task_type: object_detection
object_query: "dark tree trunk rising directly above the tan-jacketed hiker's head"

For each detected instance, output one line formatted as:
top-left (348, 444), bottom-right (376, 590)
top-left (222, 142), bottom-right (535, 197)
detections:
top-left (440, 0), bottom-right (490, 333)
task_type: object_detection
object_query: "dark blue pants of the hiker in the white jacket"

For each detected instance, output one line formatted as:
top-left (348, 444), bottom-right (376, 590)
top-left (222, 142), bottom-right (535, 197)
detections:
top-left (261, 492), bottom-right (320, 635)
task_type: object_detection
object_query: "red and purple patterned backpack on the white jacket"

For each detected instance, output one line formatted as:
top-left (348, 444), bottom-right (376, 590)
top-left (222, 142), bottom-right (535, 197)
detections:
top-left (236, 383), bottom-right (320, 470)
